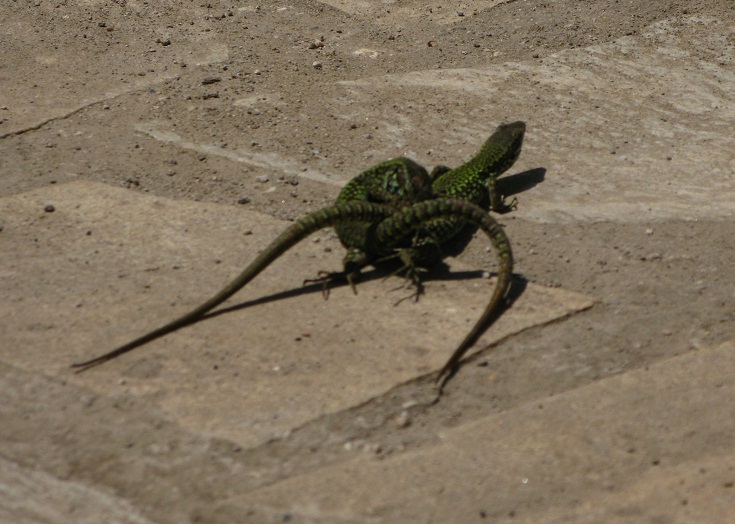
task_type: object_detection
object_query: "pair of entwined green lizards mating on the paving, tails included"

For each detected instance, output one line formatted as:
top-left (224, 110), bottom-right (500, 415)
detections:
top-left (73, 122), bottom-right (526, 380)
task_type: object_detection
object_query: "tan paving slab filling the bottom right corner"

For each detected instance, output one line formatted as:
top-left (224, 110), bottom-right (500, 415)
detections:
top-left (229, 342), bottom-right (735, 522)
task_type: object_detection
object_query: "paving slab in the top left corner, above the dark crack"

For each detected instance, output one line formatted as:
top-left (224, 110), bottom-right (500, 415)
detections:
top-left (0, 0), bottom-right (228, 138)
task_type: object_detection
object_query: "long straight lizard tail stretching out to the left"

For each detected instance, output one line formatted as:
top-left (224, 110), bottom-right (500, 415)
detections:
top-left (72, 202), bottom-right (395, 373)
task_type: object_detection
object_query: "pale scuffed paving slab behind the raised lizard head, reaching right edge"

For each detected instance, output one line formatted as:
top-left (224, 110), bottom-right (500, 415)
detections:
top-left (98, 16), bottom-right (735, 223)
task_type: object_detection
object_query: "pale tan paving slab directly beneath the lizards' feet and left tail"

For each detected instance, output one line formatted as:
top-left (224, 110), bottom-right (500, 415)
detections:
top-left (0, 182), bottom-right (593, 447)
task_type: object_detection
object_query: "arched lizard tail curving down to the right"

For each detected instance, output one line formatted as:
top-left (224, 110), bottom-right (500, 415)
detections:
top-left (376, 198), bottom-right (513, 382)
